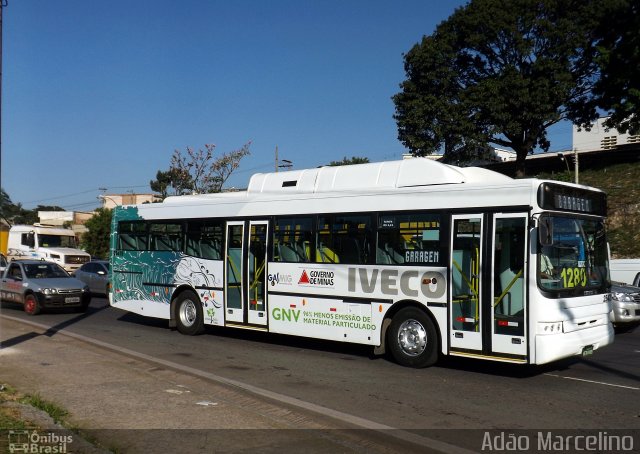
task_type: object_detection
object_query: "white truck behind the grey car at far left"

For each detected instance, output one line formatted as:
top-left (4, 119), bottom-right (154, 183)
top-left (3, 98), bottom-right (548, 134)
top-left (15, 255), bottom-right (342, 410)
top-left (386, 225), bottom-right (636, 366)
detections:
top-left (7, 224), bottom-right (91, 272)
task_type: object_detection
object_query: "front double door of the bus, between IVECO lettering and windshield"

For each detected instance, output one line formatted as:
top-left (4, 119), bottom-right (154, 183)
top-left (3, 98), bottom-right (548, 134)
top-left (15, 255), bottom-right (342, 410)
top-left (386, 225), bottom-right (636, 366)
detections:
top-left (449, 213), bottom-right (527, 362)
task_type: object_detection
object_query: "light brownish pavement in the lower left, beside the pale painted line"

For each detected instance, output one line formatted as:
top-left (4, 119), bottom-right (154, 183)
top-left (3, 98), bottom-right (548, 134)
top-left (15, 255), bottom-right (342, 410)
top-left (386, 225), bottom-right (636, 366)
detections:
top-left (0, 317), bottom-right (460, 453)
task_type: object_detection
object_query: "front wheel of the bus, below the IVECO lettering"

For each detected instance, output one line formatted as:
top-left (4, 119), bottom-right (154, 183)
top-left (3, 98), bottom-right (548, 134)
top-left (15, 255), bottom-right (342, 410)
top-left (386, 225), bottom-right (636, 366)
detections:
top-left (387, 307), bottom-right (439, 368)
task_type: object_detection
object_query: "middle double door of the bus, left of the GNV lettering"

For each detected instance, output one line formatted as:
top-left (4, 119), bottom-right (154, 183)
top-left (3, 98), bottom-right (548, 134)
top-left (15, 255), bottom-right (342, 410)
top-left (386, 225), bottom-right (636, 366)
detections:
top-left (225, 221), bottom-right (268, 325)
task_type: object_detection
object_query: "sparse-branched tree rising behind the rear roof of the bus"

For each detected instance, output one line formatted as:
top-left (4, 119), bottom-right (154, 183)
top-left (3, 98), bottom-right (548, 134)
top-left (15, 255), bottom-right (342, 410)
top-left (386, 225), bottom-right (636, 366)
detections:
top-left (149, 142), bottom-right (251, 197)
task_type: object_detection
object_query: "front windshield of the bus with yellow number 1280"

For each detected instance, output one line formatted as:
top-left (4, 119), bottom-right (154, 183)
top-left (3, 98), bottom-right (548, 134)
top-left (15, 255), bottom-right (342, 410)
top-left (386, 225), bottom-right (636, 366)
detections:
top-left (538, 215), bottom-right (608, 294)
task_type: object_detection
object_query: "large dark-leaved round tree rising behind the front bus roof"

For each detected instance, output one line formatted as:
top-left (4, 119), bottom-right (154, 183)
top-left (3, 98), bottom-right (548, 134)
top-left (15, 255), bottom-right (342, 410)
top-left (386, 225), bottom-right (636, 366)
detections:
top-left (393, 0), bottom-right (604, 176)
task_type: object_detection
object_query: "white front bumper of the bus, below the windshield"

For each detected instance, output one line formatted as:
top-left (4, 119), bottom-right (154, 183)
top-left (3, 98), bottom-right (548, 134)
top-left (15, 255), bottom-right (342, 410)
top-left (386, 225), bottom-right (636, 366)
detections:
top-left (534, 323), bottom-right (614, 364)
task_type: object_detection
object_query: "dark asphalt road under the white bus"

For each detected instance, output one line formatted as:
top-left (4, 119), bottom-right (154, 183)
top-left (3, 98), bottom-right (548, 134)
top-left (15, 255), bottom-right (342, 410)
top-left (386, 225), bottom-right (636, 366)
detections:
top-left (3, 298), bottom-right (640, 446)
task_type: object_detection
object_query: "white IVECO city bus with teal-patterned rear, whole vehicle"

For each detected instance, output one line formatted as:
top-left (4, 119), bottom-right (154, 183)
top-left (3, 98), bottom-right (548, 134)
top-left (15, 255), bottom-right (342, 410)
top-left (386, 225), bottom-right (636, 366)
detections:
top-left (109, 158), bottom-right (614, 367)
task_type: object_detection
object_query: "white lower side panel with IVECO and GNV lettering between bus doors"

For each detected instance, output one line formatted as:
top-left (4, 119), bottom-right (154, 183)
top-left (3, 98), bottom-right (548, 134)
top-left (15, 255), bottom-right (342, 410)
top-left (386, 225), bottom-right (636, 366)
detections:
top-left (268, 262), bottom-right (446, 345)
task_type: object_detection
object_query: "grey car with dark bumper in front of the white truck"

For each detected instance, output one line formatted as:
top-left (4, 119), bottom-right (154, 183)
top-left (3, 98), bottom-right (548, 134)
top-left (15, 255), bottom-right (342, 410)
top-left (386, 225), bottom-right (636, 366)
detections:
top-left (0, 260), bottom-right (91, 315)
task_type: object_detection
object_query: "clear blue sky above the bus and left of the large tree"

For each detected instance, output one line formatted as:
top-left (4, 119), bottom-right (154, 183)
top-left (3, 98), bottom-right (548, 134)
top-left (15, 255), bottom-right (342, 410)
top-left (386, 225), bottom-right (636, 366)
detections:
top-left (0, 0), bottom-right (571, 211)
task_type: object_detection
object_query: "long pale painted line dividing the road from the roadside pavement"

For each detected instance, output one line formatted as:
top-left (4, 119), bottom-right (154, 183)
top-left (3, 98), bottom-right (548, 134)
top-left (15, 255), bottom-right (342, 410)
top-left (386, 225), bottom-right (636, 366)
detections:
top-left (0, 314), bottom-right (476, 454)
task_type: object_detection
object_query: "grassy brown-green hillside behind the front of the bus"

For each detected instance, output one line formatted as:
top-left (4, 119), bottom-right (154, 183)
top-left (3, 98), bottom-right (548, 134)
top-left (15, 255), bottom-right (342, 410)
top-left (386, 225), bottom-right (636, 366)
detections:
top-left (537, 163), bottom-right (640, 258)
